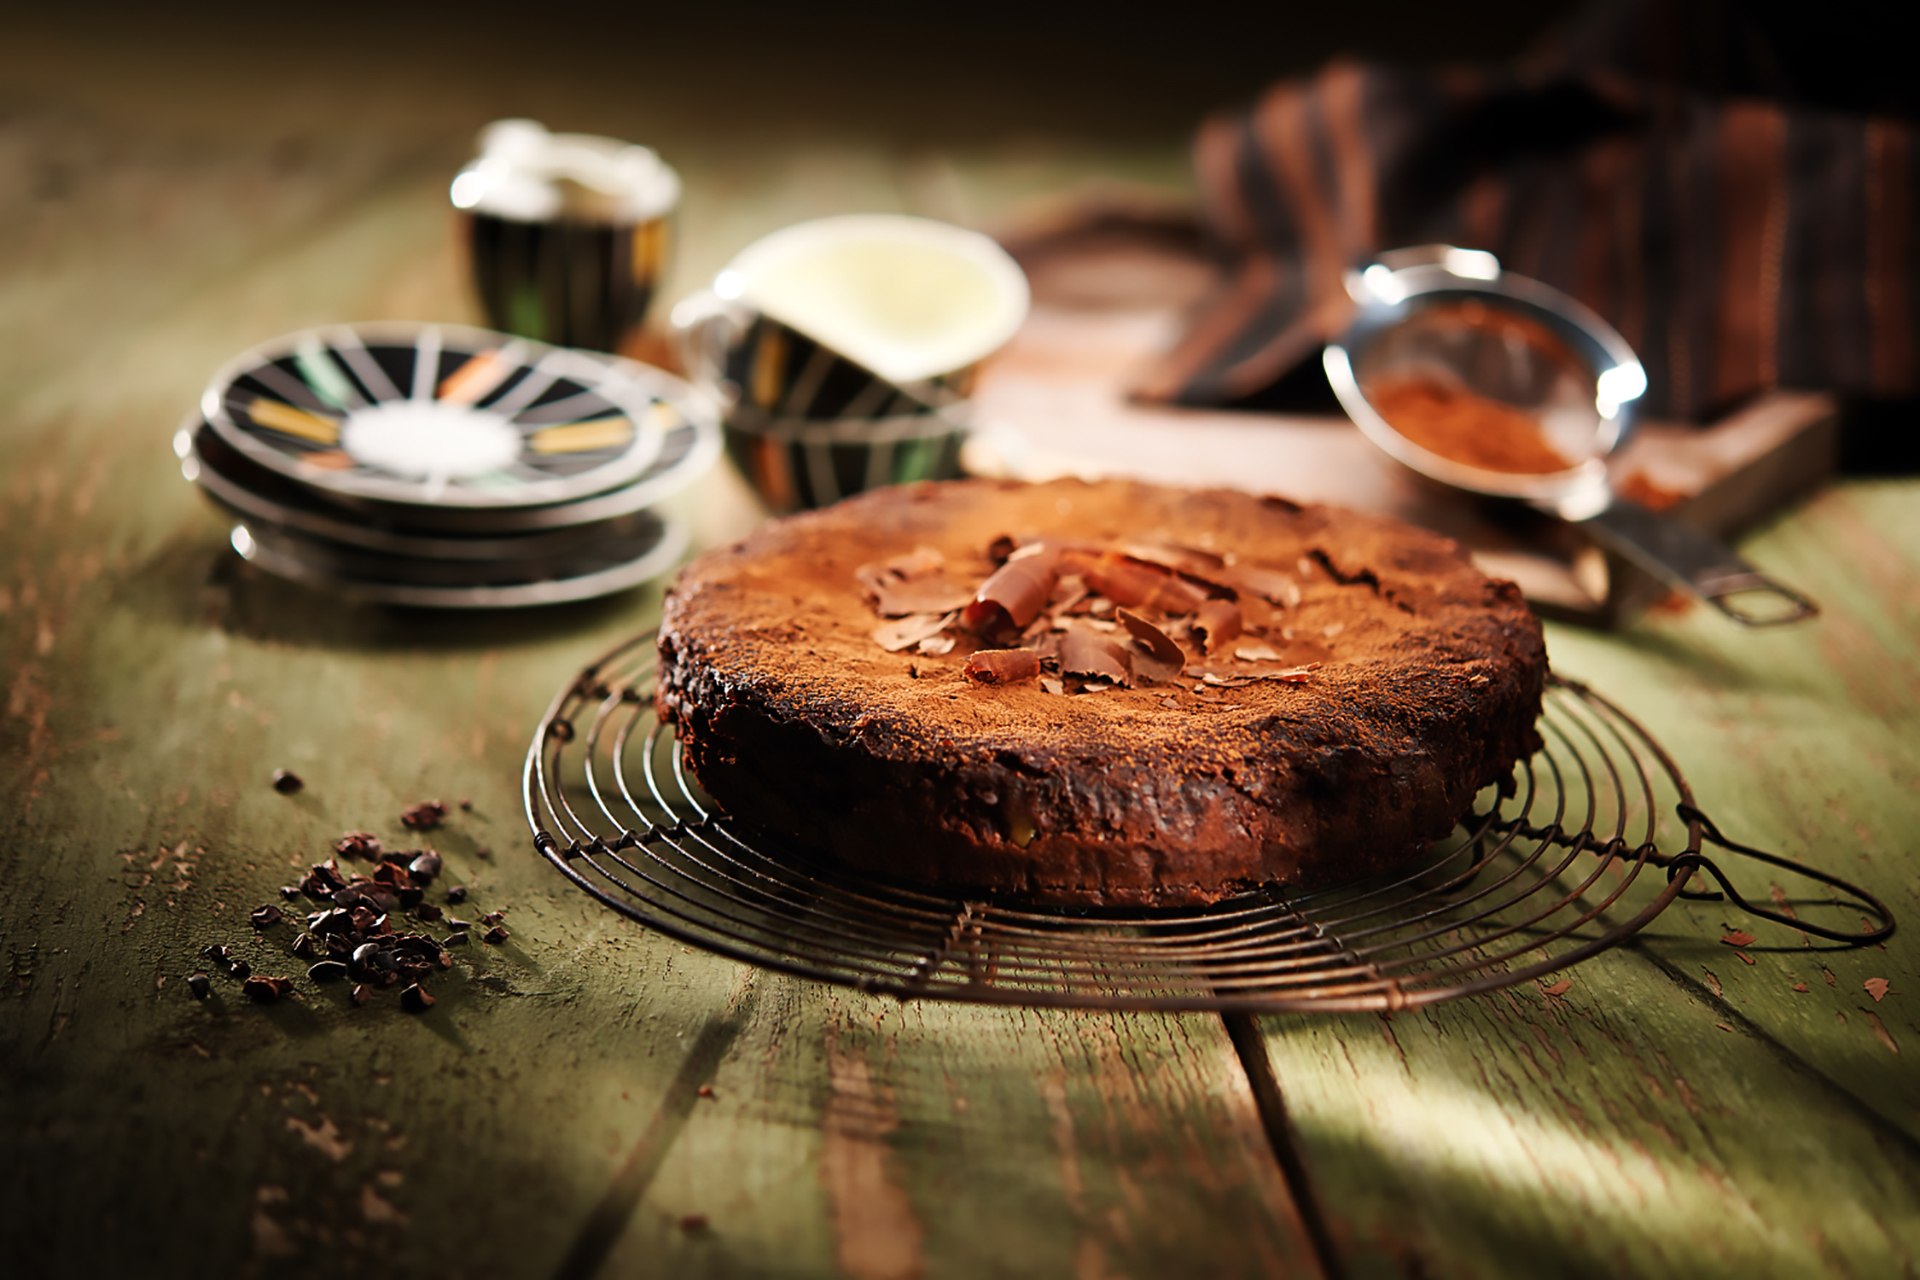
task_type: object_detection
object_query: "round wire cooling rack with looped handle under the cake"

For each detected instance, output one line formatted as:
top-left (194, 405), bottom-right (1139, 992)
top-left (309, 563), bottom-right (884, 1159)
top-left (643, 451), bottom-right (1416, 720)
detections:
top-left (522, 631), bottom-right (1893, 1013)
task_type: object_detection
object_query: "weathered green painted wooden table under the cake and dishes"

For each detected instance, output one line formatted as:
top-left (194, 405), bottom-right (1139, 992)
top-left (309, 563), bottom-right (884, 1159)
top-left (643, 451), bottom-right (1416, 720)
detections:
top-left (0, 12), bottom-right (1920, 1280)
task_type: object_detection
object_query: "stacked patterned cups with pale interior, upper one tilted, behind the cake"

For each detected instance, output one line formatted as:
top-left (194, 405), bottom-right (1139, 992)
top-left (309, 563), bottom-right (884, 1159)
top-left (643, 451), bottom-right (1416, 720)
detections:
top-left (672, 215), bottom-right (1029, 512)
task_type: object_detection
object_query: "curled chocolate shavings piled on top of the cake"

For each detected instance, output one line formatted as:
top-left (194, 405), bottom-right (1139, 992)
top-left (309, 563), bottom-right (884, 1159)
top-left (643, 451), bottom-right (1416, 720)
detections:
top-left (854, 537), bottom-right (1319, 697)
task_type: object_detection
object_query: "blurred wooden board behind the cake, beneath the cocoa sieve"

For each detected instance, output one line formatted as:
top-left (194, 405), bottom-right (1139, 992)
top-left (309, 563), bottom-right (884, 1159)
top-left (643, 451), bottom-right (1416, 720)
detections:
top-left (966, 203), bottom-right (1837, 626)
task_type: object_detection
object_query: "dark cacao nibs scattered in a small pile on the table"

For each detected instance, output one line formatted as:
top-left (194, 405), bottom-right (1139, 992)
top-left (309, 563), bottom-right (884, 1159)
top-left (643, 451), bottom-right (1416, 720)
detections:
top-left (186, 800), bottom-right (513, 1013)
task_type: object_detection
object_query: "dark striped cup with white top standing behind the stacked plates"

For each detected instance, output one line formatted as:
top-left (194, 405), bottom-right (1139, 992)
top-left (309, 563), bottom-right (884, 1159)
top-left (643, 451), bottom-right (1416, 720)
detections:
top-left (449, 119), bottom-right (680, 351)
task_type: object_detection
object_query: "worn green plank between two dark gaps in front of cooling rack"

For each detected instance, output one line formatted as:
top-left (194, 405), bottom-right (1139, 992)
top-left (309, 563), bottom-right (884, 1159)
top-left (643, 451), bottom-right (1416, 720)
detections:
top-left (609, 975), bottom-right (1315, 1280)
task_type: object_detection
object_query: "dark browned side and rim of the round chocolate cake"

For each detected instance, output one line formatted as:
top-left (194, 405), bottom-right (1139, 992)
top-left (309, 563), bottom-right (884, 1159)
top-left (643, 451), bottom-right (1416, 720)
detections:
top-left (657, 475), bottom-right (1546, 906)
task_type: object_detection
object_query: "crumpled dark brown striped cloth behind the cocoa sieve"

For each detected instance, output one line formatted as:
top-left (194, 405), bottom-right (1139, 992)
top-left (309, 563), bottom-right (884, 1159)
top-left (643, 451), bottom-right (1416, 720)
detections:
top-left (1139, 4), bottom-right (1920, 418)
